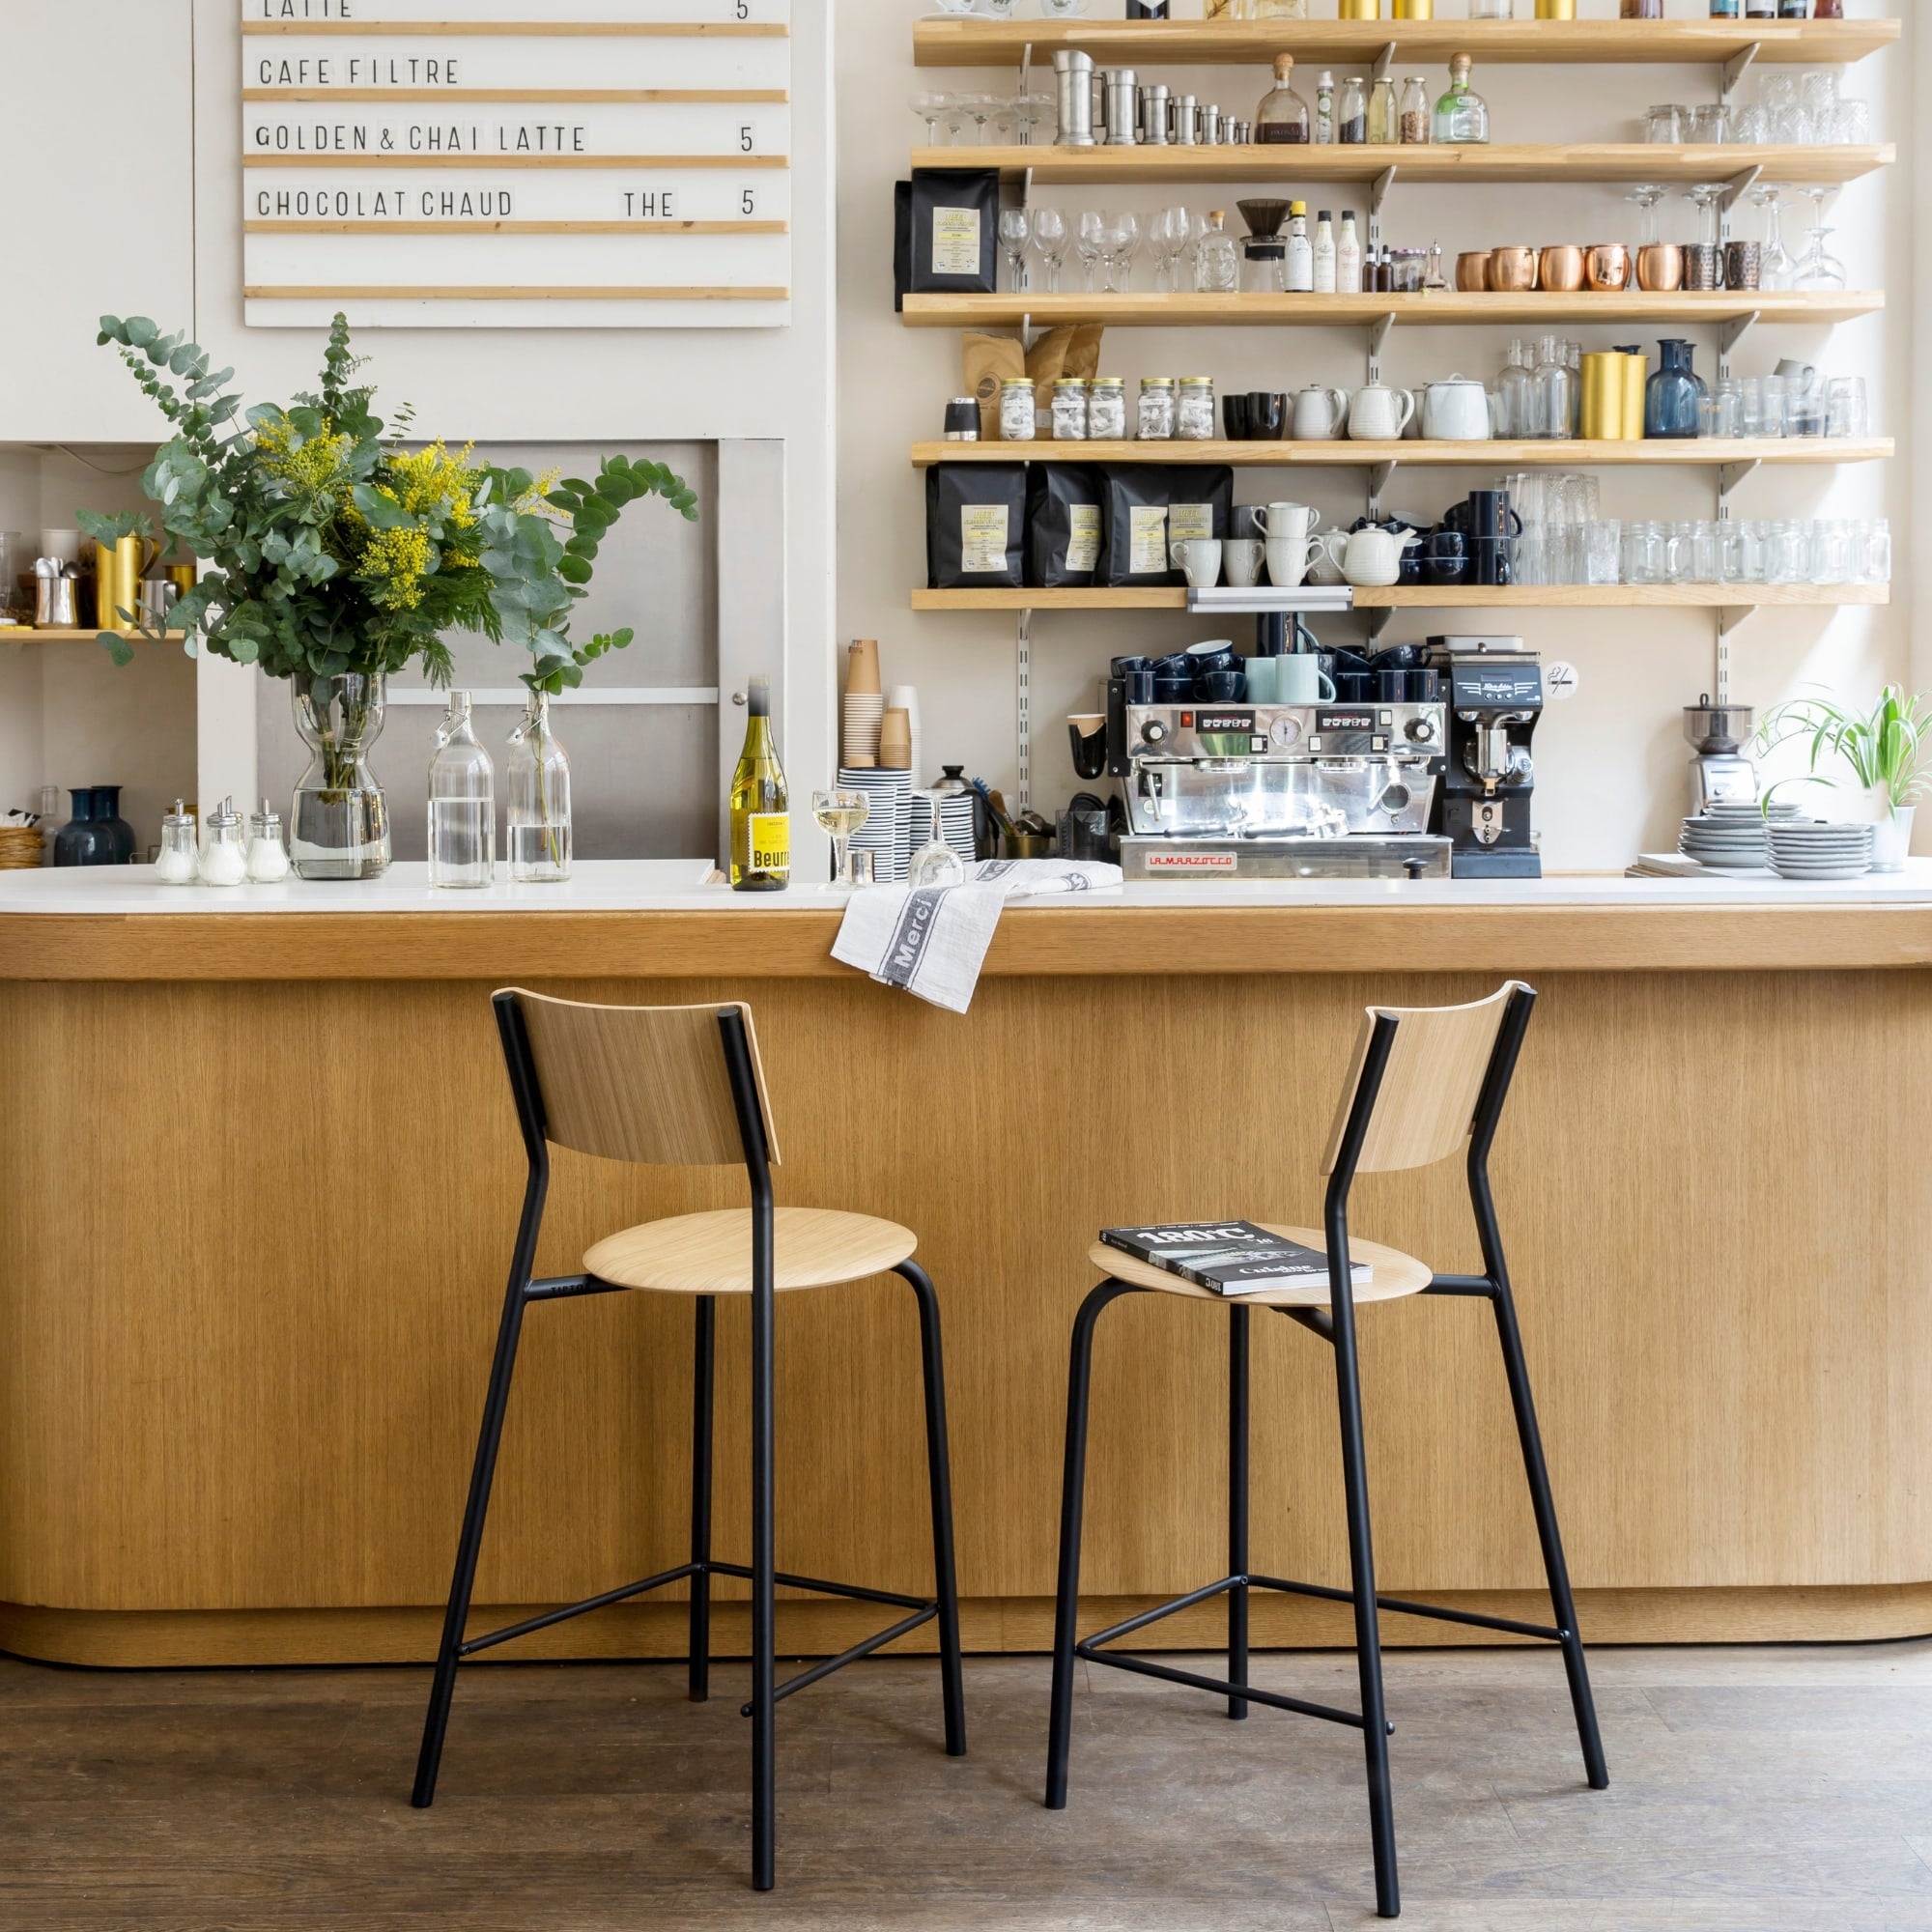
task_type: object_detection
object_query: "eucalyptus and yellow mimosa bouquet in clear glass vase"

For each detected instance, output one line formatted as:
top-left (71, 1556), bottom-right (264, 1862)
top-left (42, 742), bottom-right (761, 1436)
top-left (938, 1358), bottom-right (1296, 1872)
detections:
top-left (99, 315), bottom-right (697, 879)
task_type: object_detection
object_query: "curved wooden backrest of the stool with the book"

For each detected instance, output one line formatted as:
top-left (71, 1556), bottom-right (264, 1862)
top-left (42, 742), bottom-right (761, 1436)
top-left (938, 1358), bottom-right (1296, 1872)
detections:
top-left (1321, 980), bottom-right (1536, 1175)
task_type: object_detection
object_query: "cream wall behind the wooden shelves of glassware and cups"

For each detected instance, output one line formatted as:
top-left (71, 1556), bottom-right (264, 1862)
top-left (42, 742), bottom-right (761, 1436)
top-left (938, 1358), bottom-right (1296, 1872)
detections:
top-left (838, 0), bottom-right (1909, 869)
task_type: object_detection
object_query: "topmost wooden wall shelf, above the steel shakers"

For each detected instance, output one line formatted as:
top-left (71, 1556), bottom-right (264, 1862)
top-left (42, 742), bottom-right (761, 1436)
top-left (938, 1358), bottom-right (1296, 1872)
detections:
top-left (912, 19), bottom-right (1899, 68)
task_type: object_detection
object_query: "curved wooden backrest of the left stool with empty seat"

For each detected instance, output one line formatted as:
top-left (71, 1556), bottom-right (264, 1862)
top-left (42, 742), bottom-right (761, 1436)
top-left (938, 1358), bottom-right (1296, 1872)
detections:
top-left (495, 987), bottom-right (779, 1167)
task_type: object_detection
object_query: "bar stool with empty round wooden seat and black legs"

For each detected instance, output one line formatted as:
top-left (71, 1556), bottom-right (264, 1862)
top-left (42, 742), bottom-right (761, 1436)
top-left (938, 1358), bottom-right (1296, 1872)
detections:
top-left (413, 989), bottom-right (966, 1891)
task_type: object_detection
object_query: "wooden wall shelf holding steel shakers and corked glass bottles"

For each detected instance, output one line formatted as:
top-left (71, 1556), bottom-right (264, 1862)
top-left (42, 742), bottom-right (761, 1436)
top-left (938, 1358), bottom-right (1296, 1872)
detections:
top-left (912, 143), bottom-right (1897, 187)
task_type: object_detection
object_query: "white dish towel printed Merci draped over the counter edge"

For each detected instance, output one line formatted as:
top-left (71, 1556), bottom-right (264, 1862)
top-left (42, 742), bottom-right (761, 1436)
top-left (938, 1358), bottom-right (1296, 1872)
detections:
top-left (833, 858), bottom-right (1121, 1012)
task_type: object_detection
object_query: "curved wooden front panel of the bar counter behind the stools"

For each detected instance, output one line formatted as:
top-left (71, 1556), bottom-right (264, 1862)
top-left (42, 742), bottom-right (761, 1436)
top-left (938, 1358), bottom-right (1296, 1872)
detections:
top-left (0, 972), bottom-right (1932, 1648)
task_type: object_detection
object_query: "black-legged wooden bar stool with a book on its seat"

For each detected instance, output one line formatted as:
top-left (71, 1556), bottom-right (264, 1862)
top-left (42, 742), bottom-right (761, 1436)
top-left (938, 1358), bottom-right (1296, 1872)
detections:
top-left (1047, 983), bottom-right (1609, 1918)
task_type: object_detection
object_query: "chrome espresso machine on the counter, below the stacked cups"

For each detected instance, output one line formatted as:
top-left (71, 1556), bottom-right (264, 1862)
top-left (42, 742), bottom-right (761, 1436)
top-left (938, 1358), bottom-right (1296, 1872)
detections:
top-left (1107, 678), bottom-right (1449, 879)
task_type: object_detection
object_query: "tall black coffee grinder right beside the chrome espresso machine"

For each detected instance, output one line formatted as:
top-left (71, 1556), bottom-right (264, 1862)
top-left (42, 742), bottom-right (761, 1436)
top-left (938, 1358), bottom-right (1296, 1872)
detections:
top-left (1424, 638), bottom-right (1544, 879)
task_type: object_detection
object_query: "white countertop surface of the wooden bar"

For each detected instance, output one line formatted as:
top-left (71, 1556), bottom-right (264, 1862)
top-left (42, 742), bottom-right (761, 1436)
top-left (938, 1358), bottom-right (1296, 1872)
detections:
top-left (0, 858), bottom-right (1932, 918)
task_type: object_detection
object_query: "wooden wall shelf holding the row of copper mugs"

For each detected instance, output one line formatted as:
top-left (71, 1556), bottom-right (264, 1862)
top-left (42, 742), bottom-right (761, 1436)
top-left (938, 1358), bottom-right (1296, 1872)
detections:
top-left (904, 288), bottom-right (1886, 328)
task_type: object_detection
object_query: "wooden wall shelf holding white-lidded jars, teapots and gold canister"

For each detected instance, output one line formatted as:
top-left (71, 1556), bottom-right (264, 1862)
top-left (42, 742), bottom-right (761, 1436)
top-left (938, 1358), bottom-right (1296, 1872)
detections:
top-left (912, 437), bottom-right (1891, 469)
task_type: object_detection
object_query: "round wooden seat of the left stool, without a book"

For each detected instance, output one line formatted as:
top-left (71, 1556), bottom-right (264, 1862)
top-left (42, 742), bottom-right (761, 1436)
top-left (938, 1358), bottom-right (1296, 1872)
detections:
top-left (583, 1208), bottom-right (920, 1294)
